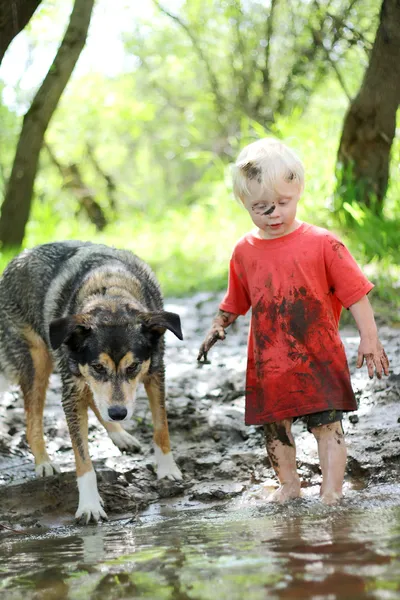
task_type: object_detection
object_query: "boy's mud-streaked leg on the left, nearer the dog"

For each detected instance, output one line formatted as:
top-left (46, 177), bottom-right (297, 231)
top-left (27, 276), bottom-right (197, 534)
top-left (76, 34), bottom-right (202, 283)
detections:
top-left (264, 419), bottom-right (300, 502)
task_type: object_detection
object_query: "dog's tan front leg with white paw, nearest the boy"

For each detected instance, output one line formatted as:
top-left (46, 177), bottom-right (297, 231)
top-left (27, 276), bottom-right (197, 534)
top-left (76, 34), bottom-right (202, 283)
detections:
top-left (144, 373), bottom-right (182, 480)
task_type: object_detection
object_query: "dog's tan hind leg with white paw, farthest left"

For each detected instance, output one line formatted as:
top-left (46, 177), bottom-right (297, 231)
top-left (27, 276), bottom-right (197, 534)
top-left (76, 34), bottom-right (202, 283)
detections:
top-left (20, 331), bottom-right (60, 477)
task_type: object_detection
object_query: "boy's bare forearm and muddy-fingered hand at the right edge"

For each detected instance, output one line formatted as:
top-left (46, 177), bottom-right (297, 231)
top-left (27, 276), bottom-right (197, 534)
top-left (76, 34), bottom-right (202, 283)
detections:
top-left (349, 296), bottom-right (389, 379)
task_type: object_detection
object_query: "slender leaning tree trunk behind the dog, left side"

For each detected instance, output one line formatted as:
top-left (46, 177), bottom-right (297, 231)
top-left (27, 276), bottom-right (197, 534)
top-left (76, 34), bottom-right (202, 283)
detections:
top-left (0, 0), bottom-right (94, 247)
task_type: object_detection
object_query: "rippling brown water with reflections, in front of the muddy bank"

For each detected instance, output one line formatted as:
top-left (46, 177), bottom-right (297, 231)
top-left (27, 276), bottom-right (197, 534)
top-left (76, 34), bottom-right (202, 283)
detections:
top-left (0, 485), bottom-right (400, 600)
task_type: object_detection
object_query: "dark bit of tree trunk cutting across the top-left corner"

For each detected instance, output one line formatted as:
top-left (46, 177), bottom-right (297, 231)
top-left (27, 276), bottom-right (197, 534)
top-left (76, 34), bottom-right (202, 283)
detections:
top-left (0, 0), bottom-right (41, 64)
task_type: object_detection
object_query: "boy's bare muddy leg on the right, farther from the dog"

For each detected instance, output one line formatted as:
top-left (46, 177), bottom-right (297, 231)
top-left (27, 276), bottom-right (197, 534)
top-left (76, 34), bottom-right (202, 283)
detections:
top-left (311, 421), bottom-right (347, 504)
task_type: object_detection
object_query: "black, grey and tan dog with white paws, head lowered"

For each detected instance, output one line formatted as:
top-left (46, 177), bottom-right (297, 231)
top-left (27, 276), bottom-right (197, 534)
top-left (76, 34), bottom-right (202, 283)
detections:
top-left (0, 241), bottom-right (183, 523)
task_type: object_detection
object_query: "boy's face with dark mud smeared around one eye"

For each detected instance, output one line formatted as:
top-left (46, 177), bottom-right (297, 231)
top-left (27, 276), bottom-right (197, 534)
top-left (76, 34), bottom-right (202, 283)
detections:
top-left (243, 179), bottom-right (302, 239)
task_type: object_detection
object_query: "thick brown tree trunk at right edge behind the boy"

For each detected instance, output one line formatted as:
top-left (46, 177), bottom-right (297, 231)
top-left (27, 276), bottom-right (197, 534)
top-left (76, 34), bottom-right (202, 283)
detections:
top-left (336, 0), bottom-right (400, 214)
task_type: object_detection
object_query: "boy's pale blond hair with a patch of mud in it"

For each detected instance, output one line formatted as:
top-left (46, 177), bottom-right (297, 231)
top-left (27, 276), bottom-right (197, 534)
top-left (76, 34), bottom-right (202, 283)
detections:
top-left (232, 138), bottom-right (304, 201)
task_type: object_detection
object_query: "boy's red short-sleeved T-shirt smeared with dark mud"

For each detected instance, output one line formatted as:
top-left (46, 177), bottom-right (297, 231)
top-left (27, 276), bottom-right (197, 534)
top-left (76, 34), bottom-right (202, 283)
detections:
top-left (220, 223), bottom-right (373, 425)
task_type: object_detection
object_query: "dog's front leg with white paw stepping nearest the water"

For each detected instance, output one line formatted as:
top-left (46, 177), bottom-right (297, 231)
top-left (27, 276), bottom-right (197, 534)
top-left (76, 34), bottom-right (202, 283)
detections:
top-left (63, 380), bottom-right (107, 523)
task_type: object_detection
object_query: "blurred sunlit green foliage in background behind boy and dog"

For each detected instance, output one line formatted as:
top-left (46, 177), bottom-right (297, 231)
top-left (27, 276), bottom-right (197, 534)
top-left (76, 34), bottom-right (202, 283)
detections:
top-left (0, 0), bottom-right (400, 318)
